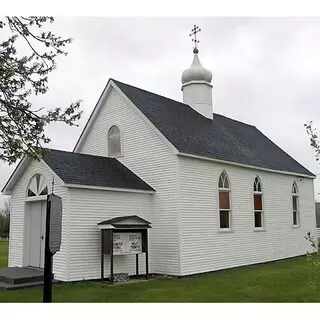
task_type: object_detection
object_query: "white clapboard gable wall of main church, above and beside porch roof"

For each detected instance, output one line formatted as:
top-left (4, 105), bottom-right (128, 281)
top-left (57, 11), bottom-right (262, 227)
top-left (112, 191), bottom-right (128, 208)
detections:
top-left (80, 89), bottom-right (180, 275)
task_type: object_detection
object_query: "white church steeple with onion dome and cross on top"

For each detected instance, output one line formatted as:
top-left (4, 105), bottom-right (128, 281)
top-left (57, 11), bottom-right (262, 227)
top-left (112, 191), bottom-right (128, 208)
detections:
top-left (181, 25), bottom-right (213, 119)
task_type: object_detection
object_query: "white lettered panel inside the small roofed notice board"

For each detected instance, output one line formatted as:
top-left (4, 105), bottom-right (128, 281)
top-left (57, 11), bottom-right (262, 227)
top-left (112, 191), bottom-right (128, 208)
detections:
top-left (113, 232), bottom-right (142, 255)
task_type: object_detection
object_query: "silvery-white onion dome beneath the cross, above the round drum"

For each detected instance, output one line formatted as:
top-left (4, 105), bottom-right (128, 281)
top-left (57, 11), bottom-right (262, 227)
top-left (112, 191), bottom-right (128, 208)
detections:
top-left (181, 48), bottom-right (212, 84)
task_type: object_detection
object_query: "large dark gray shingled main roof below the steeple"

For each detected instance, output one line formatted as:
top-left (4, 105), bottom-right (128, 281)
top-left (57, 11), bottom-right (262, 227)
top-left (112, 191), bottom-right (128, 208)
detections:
top-left (111, 79), bottom-right (314, 176)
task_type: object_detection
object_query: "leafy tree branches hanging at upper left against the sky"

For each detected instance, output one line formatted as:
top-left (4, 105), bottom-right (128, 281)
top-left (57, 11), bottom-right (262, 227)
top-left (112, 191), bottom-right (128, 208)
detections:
top-left (0, 16), bottom-right (82, 164)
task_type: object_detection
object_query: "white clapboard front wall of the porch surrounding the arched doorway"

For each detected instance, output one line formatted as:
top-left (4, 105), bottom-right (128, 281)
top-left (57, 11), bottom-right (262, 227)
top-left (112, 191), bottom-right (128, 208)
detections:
top-left (8, 161), bottom-right (67, 281)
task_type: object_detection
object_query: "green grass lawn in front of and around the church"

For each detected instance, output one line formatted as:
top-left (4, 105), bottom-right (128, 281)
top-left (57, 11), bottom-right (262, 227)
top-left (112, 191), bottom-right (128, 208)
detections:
top-left (0, 241), bottom-right (316, 302)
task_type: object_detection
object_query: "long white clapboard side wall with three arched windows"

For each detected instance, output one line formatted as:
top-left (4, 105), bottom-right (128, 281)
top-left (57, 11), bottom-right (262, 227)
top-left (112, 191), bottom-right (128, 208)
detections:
top-left (179, 157), bottom-right (315, 275)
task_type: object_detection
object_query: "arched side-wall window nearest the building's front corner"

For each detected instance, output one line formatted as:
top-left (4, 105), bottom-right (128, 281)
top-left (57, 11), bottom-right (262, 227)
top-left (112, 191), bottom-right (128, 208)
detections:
top-left (219, 171), bottom-right (231, 229)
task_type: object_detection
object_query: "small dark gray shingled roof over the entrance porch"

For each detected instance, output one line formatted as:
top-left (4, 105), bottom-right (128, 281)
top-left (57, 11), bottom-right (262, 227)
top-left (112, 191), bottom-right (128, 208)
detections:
top-left (43, 149), bottom-right (155, 191)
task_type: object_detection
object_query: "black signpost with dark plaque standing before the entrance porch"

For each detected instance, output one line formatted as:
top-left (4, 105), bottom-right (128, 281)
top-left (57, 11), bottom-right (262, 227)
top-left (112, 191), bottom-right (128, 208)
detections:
top-left (43, 194), bottom-right (62, 302)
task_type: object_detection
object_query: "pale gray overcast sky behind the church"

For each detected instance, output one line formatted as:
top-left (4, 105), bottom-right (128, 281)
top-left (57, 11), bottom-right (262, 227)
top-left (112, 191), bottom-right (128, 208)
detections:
top-left (0, 17), bottom-right (320, 206)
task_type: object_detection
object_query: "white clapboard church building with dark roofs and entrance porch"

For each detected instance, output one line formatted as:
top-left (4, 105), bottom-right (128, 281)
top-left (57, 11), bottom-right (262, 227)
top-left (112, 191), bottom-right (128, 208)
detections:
top-left (2, 38), bottom-right (316, 281)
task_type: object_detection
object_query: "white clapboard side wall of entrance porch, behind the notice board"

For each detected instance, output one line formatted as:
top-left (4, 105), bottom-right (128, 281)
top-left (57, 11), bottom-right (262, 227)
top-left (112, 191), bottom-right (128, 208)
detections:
top-left (68, 188), bottom-right (153, 281)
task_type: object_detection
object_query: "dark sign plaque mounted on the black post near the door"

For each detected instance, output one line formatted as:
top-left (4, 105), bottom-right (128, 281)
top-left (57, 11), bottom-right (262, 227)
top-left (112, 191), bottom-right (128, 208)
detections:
top-left (48, 194), bottom-right (62, 253)
